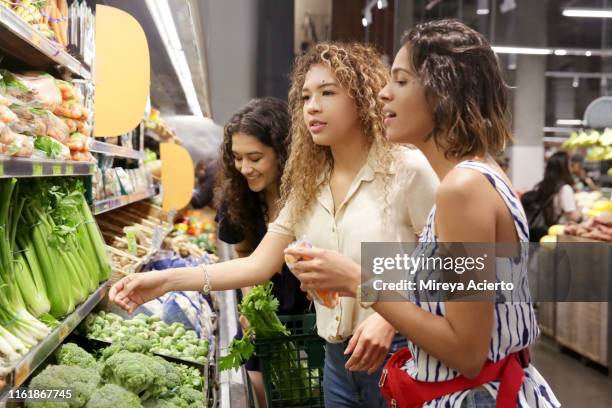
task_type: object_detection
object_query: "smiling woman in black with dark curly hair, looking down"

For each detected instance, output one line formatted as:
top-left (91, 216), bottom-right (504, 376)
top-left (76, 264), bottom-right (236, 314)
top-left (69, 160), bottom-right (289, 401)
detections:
top-left (215, 97), bottom-right (309, 407)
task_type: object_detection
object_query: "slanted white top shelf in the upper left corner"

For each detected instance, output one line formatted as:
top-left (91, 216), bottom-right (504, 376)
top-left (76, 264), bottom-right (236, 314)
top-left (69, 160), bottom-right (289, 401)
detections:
top-left (0, 6), bottom-right (91, 80)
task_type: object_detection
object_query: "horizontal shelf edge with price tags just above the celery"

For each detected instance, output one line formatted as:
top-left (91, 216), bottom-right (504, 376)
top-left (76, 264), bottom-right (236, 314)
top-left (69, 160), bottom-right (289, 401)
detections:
top-left (0, 158), bottom-right (96, 178)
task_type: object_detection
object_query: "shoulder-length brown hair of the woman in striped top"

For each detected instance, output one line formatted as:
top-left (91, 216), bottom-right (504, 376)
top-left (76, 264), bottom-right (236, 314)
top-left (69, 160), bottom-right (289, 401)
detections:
top-left (402, 20), bottom-right (512, 158)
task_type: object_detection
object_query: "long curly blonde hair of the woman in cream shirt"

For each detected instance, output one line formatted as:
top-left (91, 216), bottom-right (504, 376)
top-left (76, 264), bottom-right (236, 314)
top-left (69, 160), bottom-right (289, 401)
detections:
top-left (280, 42), bottom-right (395, 225)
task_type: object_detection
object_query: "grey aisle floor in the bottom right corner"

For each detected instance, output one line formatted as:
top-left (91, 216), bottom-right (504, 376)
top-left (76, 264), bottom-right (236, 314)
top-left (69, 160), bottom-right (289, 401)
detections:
top-left (532, 338), bottom-right (612, 408)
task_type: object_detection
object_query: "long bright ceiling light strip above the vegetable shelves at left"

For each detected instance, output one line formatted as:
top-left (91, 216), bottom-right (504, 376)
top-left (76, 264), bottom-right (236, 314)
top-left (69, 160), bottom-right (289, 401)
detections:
top-left (146, 0), bottom-right (204, 117)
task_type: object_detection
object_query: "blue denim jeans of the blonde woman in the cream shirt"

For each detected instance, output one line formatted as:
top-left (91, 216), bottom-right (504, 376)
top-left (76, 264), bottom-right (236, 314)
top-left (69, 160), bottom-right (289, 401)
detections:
top-left (323, 336), bottom-right (406, 408)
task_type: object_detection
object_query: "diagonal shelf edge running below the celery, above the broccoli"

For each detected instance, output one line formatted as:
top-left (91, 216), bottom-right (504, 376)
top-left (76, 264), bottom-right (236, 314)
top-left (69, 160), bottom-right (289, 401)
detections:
top-left (0, 283), bottom-right (108, 400)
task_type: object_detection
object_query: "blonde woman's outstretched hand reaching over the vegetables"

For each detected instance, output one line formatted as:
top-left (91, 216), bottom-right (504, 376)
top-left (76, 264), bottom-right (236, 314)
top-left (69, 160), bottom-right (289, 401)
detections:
top-left (108, 270), bottom-right (169, 313)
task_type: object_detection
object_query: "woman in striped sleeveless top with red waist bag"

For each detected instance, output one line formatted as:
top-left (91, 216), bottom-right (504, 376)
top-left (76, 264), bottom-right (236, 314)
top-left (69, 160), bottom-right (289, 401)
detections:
top-left (287, 20), bottom-right (560, 408)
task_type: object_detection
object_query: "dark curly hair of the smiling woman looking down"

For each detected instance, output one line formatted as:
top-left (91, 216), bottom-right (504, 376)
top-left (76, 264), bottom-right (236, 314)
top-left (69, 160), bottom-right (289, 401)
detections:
top-left (215, 97), bottom-right (291, 245)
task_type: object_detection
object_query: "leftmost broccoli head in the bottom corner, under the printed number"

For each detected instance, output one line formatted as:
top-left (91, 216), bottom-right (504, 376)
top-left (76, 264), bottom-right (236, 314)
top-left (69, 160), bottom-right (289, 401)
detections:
top-left (26, 365), bottom-right (100, 408)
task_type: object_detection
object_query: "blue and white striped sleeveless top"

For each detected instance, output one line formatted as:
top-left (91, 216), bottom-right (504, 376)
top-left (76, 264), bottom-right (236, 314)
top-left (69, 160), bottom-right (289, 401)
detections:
top-left (403, 160), bottom-right (561, 408)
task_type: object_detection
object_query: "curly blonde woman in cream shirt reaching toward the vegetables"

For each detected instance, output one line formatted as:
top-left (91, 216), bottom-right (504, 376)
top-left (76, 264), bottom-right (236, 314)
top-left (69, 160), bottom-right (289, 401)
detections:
top-left (110, 43), bottom-right (438, 408)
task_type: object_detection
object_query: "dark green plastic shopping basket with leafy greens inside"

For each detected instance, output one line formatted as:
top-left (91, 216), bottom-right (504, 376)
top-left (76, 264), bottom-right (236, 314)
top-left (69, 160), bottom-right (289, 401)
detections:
top-left (255, 314), bottom-right (325, 407)
